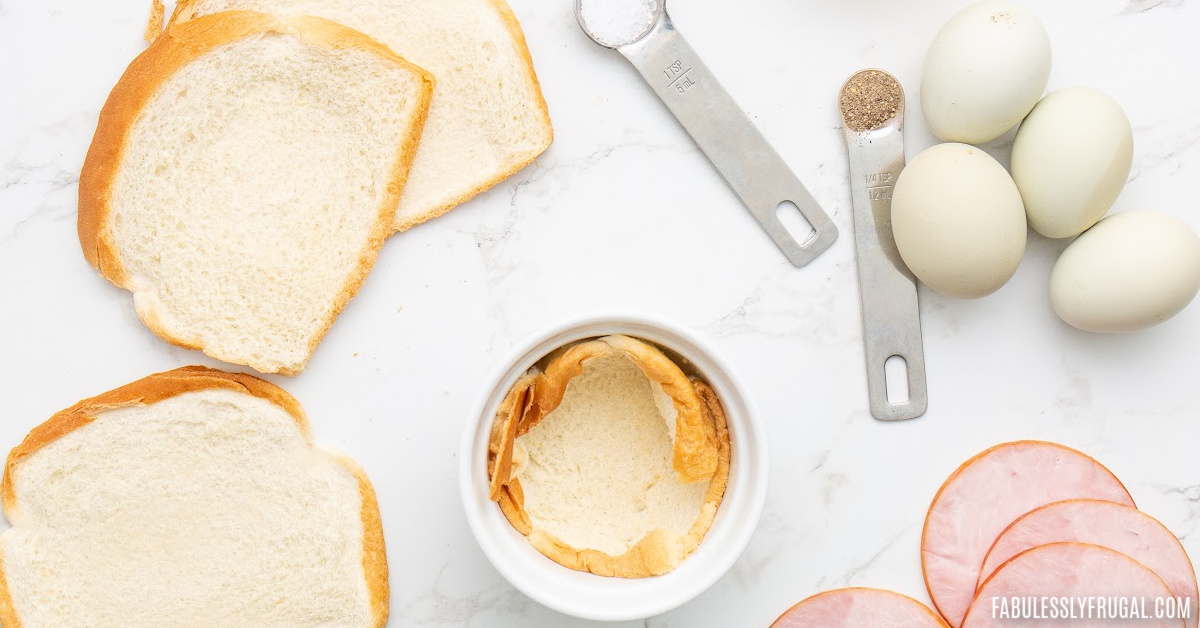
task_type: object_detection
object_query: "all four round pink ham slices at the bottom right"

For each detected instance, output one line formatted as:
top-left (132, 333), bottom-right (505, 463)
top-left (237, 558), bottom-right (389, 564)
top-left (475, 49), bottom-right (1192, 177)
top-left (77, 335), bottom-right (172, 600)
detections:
top-left (772, 441), bottom-right (1200, 628)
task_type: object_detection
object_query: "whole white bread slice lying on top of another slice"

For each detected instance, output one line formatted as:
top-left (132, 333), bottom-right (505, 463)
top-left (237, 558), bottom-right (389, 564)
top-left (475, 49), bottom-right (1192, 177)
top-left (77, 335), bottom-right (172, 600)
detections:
top-left (79, 12), bottom-right (433, 375)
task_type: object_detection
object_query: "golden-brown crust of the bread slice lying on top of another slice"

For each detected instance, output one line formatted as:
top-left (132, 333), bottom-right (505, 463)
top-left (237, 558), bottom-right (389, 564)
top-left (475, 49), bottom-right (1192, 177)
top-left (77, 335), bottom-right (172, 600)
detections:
top-left (78, 12), bottom-right (434, 375)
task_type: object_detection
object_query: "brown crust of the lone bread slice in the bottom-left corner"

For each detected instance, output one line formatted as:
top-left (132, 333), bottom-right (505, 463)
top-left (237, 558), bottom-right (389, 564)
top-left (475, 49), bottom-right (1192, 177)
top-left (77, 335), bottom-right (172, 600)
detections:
top-left (0, 366), bottom-right (390, 628)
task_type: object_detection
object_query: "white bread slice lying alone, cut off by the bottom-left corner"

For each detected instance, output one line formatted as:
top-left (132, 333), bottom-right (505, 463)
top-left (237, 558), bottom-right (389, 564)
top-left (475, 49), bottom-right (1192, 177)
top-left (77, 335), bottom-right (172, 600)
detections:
top-left (0, 366), bottom-right (389, 628)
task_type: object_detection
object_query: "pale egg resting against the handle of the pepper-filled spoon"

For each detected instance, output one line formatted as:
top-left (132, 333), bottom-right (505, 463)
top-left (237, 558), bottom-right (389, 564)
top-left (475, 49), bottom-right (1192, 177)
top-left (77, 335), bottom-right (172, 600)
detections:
top-left (892, 144), bottom-right (1026, 299)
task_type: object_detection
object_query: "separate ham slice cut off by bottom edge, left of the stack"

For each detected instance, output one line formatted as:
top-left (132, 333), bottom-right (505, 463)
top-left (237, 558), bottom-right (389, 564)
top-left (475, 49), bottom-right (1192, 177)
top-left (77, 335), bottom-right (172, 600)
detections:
top-left (770, 588), bottom-right (946, 628)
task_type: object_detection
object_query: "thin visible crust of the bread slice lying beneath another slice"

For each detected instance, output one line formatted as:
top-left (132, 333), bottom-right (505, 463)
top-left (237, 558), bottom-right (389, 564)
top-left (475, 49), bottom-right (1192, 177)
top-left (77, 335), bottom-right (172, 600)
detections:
top-left (165, 0), bottom-right (554, 233)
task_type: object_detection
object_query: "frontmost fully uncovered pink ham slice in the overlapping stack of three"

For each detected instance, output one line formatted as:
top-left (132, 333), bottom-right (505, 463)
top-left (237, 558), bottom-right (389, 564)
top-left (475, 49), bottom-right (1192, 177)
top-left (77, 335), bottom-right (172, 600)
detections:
top-left (962, 543), bottom-right (1183, 628)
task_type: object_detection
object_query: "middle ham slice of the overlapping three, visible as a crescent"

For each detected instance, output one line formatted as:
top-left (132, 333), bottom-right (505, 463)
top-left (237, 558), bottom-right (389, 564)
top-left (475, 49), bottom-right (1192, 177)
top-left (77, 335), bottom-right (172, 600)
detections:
top-left (979, 500), bottom-right (1200, 628)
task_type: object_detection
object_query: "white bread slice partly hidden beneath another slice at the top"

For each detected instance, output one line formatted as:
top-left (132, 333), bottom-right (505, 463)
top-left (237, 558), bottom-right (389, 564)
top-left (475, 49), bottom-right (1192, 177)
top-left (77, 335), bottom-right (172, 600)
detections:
top-left (172, 0), bottom-right (553, 231)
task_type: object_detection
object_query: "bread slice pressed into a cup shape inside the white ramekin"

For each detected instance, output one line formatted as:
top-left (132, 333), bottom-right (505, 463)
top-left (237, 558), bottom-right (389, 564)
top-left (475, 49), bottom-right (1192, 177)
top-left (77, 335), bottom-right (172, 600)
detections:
top-left (490, 336), bottom-right (730, 578)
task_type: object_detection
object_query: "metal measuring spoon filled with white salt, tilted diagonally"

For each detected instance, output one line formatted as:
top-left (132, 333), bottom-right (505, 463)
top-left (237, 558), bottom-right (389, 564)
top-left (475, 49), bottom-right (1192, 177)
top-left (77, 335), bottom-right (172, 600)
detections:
top-left (575, 0), bottom-right (838, 267)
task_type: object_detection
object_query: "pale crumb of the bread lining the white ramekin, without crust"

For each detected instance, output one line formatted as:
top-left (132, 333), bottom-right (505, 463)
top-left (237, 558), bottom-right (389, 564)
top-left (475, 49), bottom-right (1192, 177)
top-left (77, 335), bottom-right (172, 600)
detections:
top-left (517, 353), bottom-right (708, 556)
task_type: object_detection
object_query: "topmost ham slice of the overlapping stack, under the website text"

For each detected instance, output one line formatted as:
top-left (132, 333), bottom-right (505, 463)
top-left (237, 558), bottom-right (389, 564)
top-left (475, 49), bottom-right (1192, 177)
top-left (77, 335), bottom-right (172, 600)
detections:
top-left (962, 543), bottom-right (1183, 628)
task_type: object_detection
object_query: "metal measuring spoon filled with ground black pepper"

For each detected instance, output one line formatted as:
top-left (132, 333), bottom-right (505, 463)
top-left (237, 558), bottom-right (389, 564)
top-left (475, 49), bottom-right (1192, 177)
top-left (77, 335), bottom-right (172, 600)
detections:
top-left (838, 70), bottom-right (929, 420)
